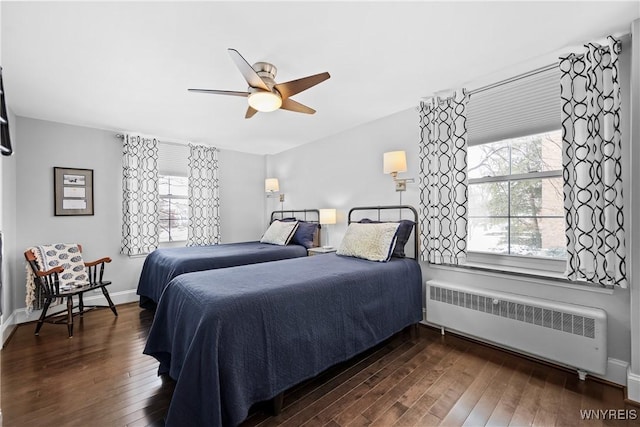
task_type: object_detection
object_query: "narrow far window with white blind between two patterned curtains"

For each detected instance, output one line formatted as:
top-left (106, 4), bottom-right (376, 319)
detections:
top-left (158, 142), bottom-right (189, 243)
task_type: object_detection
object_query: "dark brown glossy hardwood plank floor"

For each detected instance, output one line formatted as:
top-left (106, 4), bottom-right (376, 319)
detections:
top-left (0, 304), bottom-right (640, 427)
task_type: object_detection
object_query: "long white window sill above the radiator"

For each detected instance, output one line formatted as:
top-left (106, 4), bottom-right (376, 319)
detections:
top-left (429, 262), bottom-right (613, 295)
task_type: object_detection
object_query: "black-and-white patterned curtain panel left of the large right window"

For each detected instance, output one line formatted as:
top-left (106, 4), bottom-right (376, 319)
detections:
top-left (420, 89), bottom-right (468, 264)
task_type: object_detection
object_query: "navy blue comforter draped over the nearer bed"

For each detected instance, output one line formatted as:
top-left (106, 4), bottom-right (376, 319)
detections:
top-left (144, 254), bottom-right (422, 426)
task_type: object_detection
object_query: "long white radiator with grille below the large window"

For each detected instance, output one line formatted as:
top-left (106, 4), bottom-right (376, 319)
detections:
top-left (427, 280), bottom-right (607, 379)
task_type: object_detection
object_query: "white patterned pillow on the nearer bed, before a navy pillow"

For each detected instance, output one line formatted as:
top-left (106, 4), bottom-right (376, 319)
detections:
top-left (336, 222), bottom-right (399, 262)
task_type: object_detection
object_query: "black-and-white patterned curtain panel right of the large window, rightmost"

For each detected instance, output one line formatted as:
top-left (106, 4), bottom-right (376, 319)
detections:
top-left (560, 37), bottom-right (627, 288)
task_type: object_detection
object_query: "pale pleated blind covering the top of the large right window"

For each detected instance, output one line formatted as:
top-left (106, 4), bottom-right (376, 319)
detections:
top-left (467, 66), bottom-right (560, 146)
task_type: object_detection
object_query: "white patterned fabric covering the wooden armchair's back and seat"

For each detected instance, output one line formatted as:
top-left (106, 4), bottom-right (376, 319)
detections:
top-left (35, 243), bottom-right (89, 289)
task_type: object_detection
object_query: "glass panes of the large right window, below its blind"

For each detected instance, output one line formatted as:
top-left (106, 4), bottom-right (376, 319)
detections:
top-left (467, 130), bottom-right (566, 260)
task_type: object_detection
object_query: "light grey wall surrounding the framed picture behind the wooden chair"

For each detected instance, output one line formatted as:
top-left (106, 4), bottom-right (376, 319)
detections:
top-left (13, 117), bottom-right (144, 307)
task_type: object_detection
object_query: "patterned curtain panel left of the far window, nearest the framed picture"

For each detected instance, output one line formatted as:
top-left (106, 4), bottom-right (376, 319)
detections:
top-left (120, 134), bottom-right (159, 255)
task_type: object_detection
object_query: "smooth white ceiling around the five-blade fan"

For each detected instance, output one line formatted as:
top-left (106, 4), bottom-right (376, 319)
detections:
top-left (0, 1), bottom-right (640, 154)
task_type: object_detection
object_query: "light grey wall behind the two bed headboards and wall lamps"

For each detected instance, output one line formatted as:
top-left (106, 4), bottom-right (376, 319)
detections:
top-left (267, 108), bottom-right (418, 237)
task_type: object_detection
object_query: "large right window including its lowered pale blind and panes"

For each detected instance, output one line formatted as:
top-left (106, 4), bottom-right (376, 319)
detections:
top-left (467, 67), bottom-right (566, 272)
